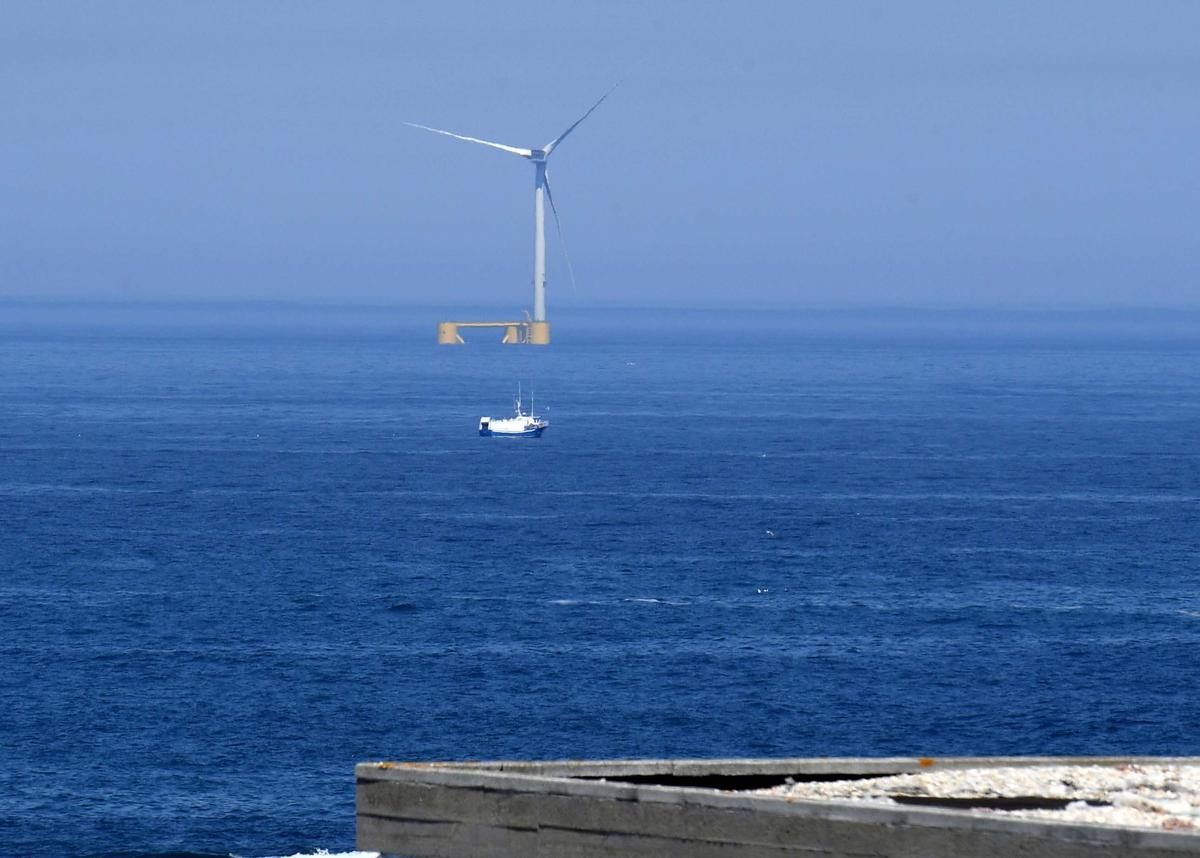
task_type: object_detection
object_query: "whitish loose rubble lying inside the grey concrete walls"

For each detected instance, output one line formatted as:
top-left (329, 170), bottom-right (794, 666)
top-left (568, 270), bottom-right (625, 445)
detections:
top-left (756, 764), bottom-right (1200, 834)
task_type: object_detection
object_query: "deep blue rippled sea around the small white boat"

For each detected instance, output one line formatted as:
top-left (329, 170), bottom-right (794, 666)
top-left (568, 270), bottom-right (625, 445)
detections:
top-left (0, 305), bottom-right (1200, 858)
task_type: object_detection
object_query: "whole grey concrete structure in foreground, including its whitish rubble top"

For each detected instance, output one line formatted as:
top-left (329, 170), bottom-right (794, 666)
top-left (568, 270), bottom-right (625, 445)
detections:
top-left (356, 757), bottom-right (1200, 858)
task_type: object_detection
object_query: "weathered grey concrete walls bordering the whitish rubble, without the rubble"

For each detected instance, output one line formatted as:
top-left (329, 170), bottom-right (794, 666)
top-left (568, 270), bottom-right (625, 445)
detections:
top-left (356, 757), bottom-right (1200, 858)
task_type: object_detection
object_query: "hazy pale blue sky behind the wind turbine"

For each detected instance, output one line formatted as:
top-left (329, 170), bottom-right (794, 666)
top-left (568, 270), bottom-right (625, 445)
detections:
top-left (0, 0), bottom-right (1200, 309)
